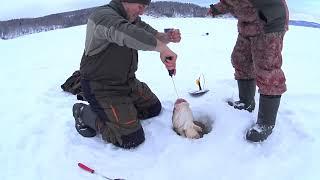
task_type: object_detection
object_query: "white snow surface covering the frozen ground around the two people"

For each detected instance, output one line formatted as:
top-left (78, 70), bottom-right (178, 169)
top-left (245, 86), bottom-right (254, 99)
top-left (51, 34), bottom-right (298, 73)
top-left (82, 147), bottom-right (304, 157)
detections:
top-left (0, 16), bottom-right (320, 180)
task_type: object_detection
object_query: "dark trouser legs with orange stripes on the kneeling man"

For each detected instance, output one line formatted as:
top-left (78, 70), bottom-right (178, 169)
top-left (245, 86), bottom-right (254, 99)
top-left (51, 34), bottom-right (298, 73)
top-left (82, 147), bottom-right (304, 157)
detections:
top-left (81, 79), bottom-right (161, 149)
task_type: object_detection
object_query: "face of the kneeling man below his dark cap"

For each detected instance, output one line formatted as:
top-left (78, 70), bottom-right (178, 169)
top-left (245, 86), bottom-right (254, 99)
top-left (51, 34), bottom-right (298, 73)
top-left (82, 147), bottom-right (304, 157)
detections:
top-left (123, 2), bottom-right (147, 22)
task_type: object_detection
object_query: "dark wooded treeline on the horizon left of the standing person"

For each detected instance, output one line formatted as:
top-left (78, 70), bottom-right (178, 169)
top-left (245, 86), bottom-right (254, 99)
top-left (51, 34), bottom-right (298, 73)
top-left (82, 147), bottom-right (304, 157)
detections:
top-left (0, 1), bottom-right (207, 39)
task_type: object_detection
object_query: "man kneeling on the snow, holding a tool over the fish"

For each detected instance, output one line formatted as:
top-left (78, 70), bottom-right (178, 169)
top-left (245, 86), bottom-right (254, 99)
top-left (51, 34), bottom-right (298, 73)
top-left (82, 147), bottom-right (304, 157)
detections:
top-left (73, 0), bottom-right (181, 149)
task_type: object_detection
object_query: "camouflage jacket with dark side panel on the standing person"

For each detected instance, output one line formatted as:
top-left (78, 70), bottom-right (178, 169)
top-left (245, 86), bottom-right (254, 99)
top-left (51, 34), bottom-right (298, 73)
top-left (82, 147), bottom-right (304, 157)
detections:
top-left (210, 0), bottom-right (289, 36)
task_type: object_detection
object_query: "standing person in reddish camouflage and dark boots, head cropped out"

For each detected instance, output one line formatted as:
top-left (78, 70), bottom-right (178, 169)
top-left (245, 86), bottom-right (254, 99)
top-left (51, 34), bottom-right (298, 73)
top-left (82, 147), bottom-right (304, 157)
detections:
top-left (209, 0), bottom-right (289, 142)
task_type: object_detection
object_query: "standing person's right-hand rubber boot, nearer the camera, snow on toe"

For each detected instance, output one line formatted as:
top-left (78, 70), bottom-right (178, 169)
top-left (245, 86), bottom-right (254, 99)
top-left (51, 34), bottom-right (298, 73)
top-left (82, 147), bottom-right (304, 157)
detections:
top-left (246, 94), bottom-right (281, 142)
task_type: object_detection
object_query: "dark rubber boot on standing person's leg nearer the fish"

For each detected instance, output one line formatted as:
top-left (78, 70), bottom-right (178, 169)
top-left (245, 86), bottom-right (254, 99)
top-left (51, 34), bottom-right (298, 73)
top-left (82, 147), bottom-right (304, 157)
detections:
top-left (228, 79), bottom-right (256, 112)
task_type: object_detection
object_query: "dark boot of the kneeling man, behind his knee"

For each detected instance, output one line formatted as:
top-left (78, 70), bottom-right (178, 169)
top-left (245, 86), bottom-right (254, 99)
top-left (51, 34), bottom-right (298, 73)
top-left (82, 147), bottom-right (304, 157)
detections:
top-left (72, 103), bottom-right (97, 137)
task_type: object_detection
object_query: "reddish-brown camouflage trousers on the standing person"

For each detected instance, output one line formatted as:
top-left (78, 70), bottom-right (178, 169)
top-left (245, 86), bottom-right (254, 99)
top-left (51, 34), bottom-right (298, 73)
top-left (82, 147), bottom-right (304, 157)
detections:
top-left (231, 32), bottom-right (287, 95)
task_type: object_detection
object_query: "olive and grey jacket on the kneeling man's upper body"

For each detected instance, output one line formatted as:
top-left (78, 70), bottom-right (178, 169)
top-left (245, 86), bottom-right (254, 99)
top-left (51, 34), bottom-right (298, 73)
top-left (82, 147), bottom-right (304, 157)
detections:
top-left (80, 0), bottom-right (157, 91)
